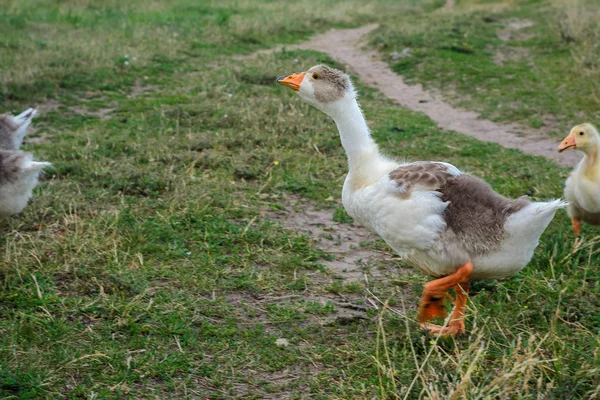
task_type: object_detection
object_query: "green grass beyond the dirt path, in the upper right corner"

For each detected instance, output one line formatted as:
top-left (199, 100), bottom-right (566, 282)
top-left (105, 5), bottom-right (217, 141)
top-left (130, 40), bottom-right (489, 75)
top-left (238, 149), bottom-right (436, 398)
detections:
top-left (371, 0), bottom-right (600, 140)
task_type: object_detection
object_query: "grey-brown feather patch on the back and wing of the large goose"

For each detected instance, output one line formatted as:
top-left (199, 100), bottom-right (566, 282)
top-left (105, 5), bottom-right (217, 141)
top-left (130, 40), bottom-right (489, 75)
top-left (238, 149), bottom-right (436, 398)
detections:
top-left (389, 162), bottom-right (529, 253)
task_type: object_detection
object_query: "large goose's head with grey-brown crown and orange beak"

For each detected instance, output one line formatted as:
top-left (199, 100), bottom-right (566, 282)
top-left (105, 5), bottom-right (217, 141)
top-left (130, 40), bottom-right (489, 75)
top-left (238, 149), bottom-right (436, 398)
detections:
top-left (277, 65), bottom-right (356, 116)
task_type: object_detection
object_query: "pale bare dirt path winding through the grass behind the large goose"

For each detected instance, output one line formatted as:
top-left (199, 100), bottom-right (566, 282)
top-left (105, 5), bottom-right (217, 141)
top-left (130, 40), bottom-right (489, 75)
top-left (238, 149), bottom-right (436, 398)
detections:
top-left (241, 23), bottom-right (581, 167)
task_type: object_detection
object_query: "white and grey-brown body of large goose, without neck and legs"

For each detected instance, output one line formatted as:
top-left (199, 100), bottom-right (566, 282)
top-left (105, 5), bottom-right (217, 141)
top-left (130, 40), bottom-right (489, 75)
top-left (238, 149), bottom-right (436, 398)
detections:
top-left (342, 162), bottom-right (564, 279)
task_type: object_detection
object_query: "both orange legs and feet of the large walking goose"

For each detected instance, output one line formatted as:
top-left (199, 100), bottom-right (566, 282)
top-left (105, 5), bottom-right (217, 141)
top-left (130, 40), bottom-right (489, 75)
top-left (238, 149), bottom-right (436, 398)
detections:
top-left (418, 261), bottom-right (473, 335)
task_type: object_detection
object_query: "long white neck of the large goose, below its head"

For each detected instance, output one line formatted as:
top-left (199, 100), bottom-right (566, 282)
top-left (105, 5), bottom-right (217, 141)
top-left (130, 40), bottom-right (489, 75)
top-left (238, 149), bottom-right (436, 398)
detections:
top-left (329, 96), bottom-right (379, 165)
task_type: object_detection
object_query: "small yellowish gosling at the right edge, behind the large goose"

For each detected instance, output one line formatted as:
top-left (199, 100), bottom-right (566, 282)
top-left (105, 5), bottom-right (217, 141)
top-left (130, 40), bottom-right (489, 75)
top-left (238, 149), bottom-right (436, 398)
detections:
top-left (558, 124), bottom-right (600, 235)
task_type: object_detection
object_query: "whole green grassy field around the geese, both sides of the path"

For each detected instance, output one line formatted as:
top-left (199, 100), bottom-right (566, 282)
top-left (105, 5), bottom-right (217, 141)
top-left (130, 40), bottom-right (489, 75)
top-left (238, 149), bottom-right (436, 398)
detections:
top-left (0, 0), bottom-right (600, 399)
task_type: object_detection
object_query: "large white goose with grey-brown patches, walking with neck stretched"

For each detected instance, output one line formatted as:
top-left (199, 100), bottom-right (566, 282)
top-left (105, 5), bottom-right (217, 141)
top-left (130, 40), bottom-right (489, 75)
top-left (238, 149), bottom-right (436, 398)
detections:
top-left (277, 65), bottom-right (566, 335)
